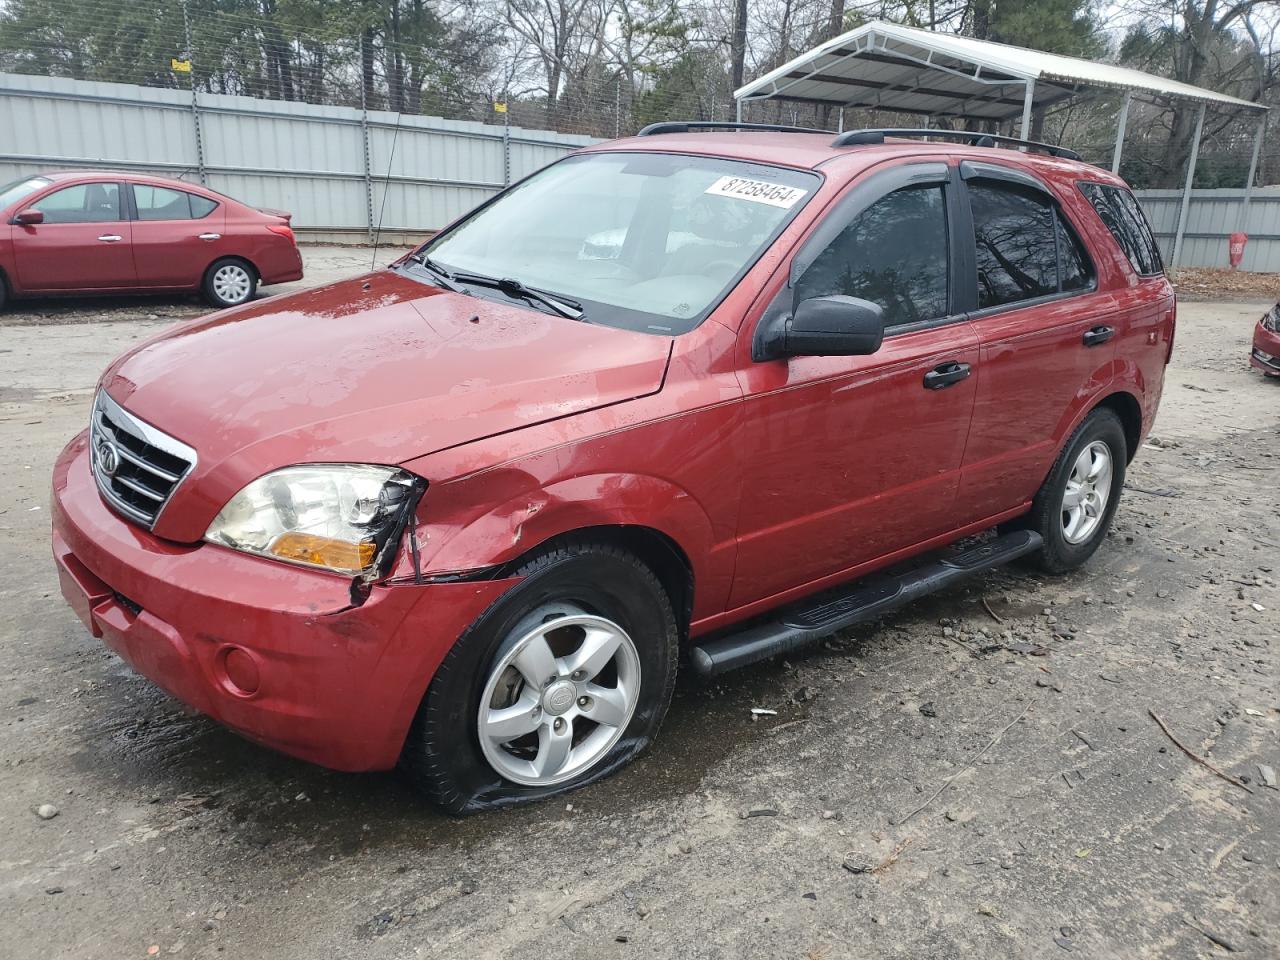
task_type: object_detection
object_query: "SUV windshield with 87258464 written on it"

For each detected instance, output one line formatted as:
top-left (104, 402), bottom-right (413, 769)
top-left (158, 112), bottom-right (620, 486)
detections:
top-left (424, 152), bottom-right (820, 335)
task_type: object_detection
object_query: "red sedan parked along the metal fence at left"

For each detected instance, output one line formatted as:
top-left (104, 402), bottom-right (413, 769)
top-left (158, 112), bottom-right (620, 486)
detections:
top-left (0, 170), bottom-right (302, 307)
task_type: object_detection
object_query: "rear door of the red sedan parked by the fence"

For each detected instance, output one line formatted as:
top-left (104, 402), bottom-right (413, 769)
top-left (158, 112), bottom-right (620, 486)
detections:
top-left (128, 183), bottom-right (225, 288)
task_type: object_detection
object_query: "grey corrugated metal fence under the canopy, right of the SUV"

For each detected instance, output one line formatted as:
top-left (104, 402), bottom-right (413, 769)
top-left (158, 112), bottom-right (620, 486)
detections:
top-left (1135, 187), bottom-right (1280, 273)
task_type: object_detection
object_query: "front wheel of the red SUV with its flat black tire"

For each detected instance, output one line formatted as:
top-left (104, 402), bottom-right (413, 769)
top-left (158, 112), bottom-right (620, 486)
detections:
top-left (401, 538), bottom-right (680, 815)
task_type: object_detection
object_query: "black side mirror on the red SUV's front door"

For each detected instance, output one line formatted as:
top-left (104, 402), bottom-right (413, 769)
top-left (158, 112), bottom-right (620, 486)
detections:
top-left (753, 296), bottom-right (884, 360)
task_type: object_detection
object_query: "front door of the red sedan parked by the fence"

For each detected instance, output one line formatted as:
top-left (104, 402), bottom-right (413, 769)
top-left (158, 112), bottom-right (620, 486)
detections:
top-left (10, 180), bottom-right (137, 293)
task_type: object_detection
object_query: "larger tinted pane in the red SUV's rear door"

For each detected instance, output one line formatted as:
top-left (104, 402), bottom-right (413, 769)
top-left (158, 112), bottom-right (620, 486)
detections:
top-left (969, 180), bottom-right (1057, 308)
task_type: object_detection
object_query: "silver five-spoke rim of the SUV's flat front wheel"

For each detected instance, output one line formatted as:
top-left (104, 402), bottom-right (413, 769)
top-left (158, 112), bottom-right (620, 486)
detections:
top-left (477, 604), bottom-right (640, 787)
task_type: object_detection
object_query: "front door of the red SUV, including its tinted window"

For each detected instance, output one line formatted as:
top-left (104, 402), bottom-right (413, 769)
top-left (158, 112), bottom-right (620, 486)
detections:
top-left (731, 163), bottom-right (979, 607)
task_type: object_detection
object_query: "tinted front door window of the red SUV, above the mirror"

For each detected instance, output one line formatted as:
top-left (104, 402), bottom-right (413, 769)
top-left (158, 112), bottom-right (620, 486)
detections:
top-left (796, 186), bottom-right (950, 326)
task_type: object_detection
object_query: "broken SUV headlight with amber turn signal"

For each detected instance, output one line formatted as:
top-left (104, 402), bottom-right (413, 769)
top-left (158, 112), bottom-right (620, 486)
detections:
top-left (205, 463), bottom-right (422, 576)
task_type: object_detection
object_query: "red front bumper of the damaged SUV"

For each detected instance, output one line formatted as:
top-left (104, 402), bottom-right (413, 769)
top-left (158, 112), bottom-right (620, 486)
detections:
top-left (52, 434), bottom-right (511, 771)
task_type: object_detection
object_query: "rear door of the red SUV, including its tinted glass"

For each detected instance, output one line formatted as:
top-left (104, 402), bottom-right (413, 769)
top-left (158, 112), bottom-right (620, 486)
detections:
top-left (956, 161), bottom-right (1119, 522)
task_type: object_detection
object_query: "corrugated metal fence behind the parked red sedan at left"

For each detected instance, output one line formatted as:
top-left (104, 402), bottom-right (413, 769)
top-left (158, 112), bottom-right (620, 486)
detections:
top-left (0, 74), bottom-right (595, 233)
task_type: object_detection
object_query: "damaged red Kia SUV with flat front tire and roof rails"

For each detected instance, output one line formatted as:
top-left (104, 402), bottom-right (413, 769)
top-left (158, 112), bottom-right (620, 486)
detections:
top-left (52, 124), bottom-right (1174, 813)
